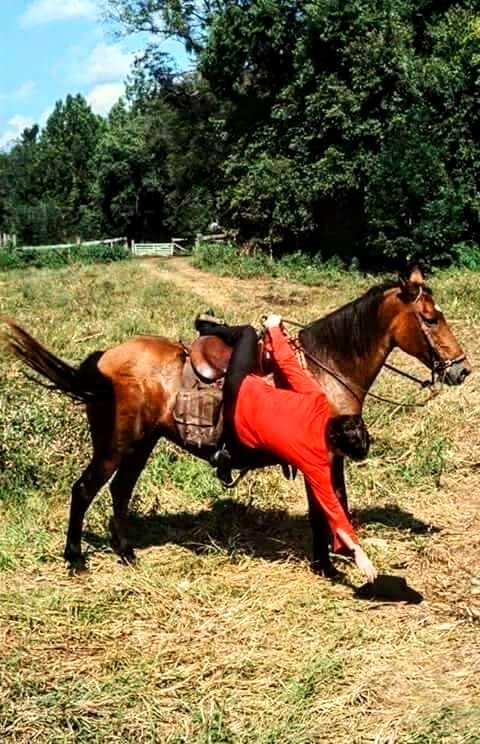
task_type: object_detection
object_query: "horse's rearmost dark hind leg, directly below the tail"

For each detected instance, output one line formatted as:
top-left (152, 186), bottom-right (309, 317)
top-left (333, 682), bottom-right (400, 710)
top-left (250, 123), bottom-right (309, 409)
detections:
top-left (64, 454), bottom-right (118, 567)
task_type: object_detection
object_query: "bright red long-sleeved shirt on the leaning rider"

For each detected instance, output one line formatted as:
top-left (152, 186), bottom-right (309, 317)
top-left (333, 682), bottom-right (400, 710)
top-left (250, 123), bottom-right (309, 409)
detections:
top-left (234, 327), bottom-right (358, 547)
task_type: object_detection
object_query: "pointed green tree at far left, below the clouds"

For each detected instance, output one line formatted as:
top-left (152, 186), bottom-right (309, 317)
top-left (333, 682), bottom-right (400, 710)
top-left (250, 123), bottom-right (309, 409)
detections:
top-left (0, 96), bottom-right (103, 244)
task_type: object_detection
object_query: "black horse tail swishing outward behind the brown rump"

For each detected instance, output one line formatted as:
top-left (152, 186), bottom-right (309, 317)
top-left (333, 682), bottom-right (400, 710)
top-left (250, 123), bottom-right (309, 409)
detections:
top-left (6, 320), bottom-right (111, 403)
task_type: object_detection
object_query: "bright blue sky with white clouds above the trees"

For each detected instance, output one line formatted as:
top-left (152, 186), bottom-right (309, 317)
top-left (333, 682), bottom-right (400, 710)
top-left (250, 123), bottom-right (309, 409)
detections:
top-left (0, 0), bottom-right (191, 148)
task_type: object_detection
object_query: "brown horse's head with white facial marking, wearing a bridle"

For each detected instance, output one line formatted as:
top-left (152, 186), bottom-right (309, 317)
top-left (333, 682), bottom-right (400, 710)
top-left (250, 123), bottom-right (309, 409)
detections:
top-left (390, 268), bottom-right (471, 385)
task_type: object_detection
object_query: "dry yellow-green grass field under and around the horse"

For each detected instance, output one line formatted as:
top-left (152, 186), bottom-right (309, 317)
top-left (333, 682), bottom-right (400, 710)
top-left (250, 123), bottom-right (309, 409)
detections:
top-left (0, 254), bottom-right (480, 744)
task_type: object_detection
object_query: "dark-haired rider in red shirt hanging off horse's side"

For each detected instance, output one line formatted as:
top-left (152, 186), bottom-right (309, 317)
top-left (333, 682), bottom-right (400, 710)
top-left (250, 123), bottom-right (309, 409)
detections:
top-left (195, 314), bottom-right (377, 582)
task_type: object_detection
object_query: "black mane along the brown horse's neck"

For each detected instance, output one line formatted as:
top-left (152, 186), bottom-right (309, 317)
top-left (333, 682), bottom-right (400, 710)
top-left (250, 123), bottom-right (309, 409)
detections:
top-left (300, 281), bottom-right (400, 358)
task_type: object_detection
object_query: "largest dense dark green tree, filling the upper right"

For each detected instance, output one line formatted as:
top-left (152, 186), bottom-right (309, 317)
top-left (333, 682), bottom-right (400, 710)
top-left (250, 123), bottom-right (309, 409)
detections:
top-left (200, 0), bottom-right (480, 265)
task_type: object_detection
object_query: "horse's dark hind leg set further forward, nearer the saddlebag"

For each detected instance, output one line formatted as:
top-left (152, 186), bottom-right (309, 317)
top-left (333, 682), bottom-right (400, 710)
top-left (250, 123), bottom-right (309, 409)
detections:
top-left (110, 434), bottom-right (159, 563)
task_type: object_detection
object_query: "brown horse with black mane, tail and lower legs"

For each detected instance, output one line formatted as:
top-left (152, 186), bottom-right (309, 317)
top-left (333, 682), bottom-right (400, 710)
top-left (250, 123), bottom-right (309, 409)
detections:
top-left (2, 270), bottom-right (470, 575)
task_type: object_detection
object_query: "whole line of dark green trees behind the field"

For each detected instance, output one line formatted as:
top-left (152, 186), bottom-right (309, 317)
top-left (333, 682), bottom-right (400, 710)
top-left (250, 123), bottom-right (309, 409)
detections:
top-left (0, 0), bottom-right (480, 268)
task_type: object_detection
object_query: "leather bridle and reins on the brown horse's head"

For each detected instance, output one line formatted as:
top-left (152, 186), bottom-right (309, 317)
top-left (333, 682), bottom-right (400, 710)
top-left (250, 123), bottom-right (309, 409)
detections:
top-left (283, 286), bottom-right (465, 408)
